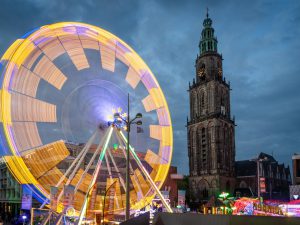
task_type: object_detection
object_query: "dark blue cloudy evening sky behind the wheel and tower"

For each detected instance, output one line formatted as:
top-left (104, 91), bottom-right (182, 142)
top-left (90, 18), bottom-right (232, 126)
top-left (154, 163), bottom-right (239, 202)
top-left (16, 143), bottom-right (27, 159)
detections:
top-left (0, 0), bottom-right (300, 174)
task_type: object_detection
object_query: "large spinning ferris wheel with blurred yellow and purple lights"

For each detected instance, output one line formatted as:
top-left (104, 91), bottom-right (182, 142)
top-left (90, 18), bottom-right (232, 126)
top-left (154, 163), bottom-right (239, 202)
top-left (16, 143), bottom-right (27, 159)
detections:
top-left (0, 22), bottom-right (173, 222)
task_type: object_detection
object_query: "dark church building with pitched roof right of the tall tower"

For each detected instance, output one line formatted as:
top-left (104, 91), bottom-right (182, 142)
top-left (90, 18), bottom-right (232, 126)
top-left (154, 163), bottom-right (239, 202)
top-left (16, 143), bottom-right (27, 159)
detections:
top-left (235, 152), bottom-right (292, 199)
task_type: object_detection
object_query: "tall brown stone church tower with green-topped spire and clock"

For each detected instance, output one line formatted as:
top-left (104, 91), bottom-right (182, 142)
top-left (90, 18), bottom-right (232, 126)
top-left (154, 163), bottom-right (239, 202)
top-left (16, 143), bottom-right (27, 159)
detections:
top-left (187, 12), bottom-right (235, 202)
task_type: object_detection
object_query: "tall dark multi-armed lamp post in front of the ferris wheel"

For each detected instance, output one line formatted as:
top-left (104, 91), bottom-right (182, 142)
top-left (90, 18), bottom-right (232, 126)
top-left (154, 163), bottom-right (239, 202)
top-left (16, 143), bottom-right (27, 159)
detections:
top-left (114, 94), bottom-right (143, 220)
